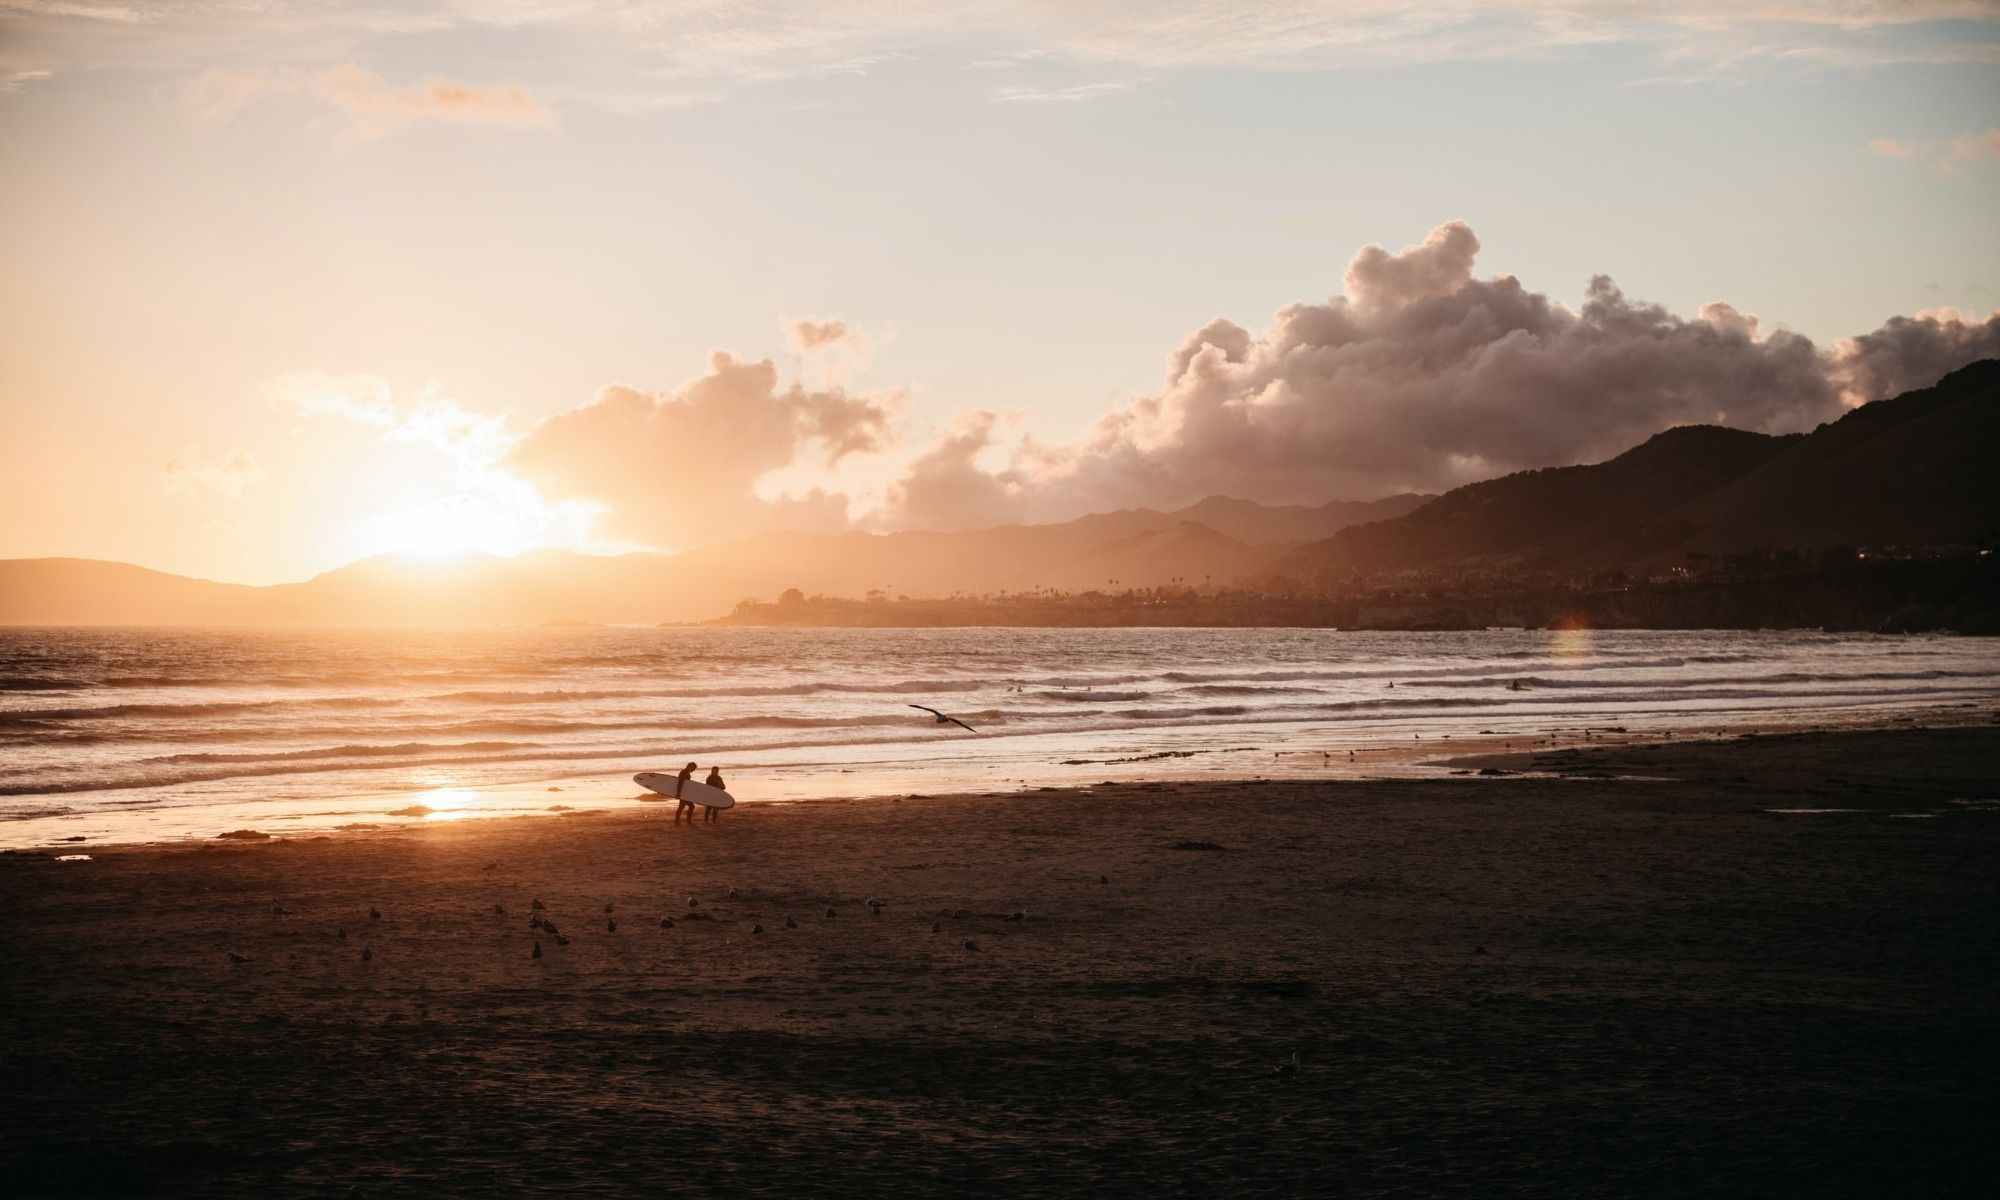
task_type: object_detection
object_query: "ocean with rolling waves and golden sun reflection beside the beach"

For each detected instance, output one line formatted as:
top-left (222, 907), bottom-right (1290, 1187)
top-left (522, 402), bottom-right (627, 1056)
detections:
top-left (0, 628), bottom-right (2000, 846)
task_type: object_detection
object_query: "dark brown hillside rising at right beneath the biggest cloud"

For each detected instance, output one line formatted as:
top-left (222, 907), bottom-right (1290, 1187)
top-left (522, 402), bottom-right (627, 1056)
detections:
top-left (1274, 360), bottom-right (2000, 578)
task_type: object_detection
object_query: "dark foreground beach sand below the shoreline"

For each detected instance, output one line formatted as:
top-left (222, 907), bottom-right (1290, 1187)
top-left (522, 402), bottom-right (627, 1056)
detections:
top-left (0, 730), bottom-right (2000, 1196)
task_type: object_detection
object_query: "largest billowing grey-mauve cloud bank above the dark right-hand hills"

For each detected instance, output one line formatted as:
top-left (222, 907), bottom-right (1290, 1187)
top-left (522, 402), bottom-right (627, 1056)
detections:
top-left (872, 222), bottom-right (2000, 528)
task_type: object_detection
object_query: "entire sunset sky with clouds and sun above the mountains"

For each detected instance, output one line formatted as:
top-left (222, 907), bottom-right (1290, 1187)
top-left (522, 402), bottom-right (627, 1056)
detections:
top-left (0, 0), bottom-right (2000, 584)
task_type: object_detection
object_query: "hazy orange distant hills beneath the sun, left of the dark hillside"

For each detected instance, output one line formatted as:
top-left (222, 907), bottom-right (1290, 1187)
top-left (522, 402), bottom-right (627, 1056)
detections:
top-left (0, 496), bottom-right (1424, 628)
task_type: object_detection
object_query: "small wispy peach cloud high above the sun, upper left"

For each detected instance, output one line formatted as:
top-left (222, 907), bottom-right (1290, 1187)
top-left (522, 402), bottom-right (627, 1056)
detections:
top-left (184, 62), bottom-right (556, 136)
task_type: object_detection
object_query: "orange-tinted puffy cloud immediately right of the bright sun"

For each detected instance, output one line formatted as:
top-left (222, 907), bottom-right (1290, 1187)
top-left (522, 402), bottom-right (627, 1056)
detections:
top-left (504, 354), bottom-right (890, 546)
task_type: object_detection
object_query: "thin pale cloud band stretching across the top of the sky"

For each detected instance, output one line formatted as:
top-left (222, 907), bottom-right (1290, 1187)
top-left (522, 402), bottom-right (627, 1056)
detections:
top-left (19, 0), bottom-right (2000, 101)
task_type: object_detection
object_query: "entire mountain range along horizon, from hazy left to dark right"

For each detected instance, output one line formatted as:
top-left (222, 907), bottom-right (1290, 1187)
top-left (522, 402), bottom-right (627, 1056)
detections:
top-left (0, 360), bottom-right (2000, 626)
